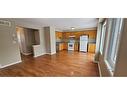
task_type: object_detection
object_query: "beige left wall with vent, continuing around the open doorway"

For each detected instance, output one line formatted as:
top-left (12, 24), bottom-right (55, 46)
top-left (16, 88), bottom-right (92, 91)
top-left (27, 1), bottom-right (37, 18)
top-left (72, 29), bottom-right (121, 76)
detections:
top-left (0, 18), bottom-right (46, 67)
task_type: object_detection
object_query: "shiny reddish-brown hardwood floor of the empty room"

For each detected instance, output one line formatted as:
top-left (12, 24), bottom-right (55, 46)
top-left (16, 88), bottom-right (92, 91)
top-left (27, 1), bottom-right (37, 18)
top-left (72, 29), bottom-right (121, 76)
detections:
top-left (0, 51), bottom-right (99, 77)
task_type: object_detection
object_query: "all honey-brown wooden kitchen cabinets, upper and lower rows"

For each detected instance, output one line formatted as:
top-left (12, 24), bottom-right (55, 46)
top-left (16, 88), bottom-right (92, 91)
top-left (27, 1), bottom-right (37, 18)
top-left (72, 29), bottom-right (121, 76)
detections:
top-left (56, 30), bottom-right (97, 53)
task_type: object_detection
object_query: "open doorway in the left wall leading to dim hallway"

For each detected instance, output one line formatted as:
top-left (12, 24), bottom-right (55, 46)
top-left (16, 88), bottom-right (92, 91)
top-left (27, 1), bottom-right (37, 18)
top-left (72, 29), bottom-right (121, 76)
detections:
top-left (16, 26), bottom-right (40, 60)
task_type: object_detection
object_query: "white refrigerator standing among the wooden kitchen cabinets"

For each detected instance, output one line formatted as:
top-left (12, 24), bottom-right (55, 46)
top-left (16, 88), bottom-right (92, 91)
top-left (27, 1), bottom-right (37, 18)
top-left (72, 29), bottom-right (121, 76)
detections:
top-left (79, 35), bottom-right (88, 52)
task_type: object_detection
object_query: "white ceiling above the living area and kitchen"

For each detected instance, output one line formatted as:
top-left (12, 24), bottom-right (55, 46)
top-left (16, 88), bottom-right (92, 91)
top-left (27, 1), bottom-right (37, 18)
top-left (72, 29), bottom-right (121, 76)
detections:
top-left (13, 18), bottom-right (98, 31)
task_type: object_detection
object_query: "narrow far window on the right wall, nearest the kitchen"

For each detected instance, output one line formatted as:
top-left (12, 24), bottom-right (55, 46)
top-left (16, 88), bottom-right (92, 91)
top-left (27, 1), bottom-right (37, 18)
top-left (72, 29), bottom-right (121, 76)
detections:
top-left (100, 21), bottom-right (106, 54)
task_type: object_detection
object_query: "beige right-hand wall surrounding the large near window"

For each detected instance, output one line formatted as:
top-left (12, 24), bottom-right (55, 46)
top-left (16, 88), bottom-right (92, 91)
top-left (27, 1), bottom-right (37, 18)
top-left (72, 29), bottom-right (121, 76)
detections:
top-left (99, 19), bottom-right (127, 77)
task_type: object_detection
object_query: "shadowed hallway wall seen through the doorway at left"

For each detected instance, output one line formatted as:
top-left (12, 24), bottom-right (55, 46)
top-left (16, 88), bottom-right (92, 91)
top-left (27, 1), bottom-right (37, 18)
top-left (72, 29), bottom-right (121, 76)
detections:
top-left (16, 27), bottom-right (35, 55)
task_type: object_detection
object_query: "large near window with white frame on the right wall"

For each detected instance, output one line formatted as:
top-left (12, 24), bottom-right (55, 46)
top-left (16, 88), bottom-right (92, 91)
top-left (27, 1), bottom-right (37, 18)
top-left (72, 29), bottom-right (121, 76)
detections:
top-left (106, 18), bottom-right (122, 70)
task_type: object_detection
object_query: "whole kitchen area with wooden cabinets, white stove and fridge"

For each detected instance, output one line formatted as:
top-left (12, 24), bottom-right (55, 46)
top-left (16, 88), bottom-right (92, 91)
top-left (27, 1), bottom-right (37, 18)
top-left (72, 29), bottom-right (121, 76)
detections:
top-left (56, 28), bottom-right (97, 53)
